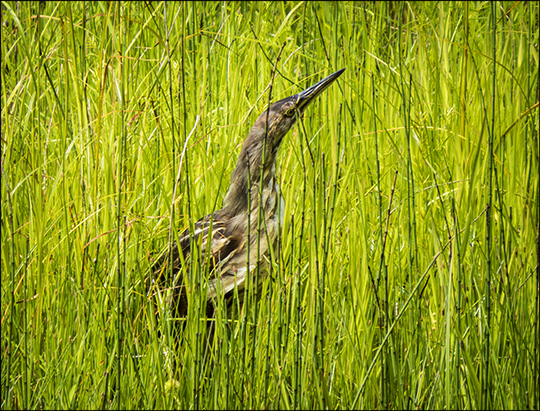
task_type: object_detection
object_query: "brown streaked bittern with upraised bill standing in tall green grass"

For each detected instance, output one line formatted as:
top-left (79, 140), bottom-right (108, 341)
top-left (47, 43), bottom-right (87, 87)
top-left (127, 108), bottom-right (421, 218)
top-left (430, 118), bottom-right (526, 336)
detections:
top-left (154, 68), bottom-right (345, 326)
